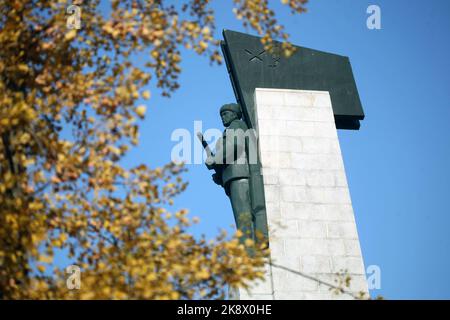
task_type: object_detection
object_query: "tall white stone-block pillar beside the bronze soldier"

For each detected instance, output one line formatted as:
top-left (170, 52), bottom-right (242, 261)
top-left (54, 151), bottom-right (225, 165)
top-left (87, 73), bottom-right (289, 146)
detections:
top-left (240, 88), bottom-right (368, 299)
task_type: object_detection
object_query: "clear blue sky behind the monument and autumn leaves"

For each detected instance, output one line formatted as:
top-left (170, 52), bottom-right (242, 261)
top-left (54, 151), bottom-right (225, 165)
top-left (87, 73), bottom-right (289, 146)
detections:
top-left (118, 0), bottom-right (450, 299)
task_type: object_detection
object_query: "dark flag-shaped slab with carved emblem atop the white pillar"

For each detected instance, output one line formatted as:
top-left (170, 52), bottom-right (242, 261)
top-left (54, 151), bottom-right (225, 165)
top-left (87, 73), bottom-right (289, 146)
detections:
top-left (222, 30), bottom-right (364, 130)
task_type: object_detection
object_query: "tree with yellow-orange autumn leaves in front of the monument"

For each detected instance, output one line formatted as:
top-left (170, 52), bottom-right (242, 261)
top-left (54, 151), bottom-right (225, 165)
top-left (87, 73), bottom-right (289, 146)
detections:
top-left (0, 0), bottom-right (306, 299)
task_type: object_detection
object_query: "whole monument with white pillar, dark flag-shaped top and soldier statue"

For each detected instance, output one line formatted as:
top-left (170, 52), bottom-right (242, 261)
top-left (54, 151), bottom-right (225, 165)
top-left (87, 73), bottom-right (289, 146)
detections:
top-left (207, 30), bottom-right (368, 299)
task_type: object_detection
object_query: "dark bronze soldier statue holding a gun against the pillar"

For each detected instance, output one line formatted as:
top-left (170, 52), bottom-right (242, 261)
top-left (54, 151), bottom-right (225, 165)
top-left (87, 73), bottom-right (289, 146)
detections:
top-left (199, 103), bottom-right (268, 245)
